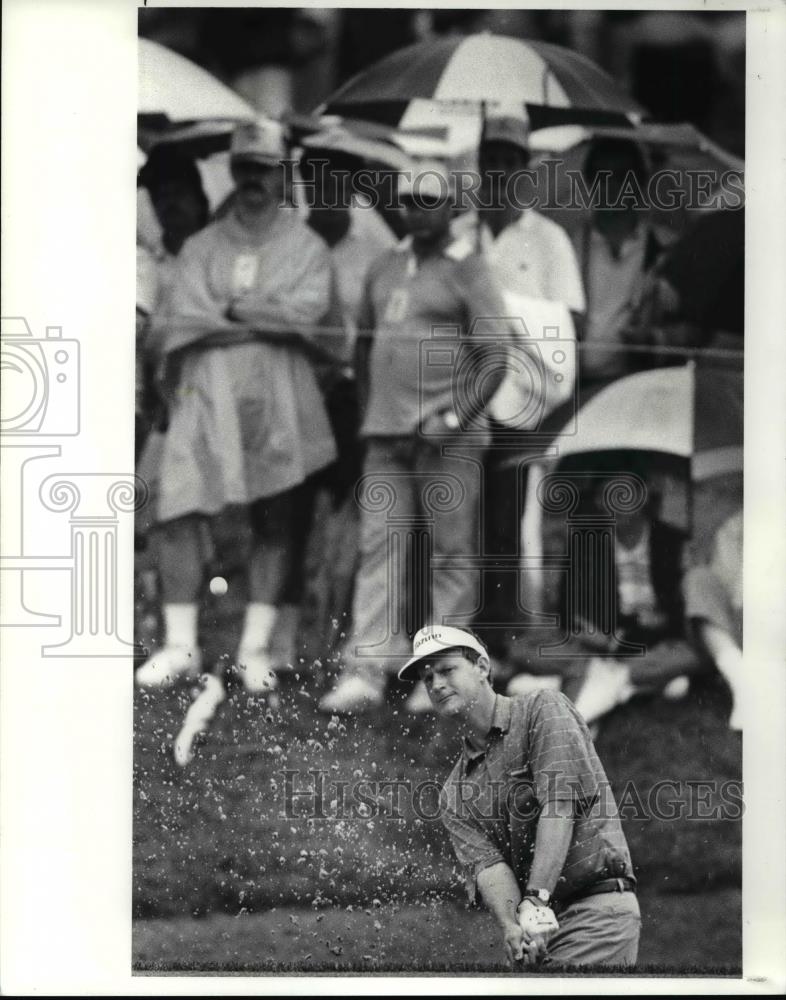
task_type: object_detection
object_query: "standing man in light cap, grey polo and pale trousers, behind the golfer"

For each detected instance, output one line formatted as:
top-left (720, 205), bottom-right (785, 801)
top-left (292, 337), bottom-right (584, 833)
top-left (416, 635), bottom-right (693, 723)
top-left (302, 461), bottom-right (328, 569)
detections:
top-left (320, 164), bottom-right (504, 712)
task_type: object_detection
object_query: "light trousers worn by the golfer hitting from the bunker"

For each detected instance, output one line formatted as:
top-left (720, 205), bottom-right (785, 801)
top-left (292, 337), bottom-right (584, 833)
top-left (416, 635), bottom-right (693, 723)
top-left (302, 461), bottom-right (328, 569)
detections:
top-left (546, 892), bottom-right (641, 966)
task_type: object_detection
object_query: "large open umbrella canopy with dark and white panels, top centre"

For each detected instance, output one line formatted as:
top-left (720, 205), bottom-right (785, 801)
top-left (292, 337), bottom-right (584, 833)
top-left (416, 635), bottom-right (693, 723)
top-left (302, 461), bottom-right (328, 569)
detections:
top-left (324, 33), bottom-right (645, 128)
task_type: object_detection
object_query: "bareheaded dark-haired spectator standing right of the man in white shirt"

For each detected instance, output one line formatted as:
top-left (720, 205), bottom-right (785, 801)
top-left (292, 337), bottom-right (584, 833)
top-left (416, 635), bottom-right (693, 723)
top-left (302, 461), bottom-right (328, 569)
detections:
top-left (579, 139), bottom-right (663, 398)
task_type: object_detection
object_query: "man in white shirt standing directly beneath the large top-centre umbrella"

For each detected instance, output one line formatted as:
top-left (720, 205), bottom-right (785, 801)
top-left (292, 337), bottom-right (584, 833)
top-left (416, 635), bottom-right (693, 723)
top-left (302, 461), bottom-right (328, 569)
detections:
top-left (472, 117), bottom-right (584, 621)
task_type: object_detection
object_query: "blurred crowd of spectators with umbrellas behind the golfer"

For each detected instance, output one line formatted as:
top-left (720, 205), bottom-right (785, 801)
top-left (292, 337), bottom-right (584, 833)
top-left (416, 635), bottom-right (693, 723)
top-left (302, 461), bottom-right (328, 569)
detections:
top-left (137, 8), bottom-right (745, 762)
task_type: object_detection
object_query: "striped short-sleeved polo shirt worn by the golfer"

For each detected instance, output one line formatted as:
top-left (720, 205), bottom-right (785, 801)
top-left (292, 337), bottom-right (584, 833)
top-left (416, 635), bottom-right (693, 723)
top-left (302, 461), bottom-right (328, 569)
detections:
top-left (440, 691), bottom-right (634, 901)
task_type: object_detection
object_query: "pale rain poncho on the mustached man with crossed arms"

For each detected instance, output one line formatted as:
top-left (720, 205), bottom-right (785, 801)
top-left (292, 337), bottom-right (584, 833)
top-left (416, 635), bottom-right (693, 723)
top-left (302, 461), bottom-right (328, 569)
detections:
top-left (157, 209), bottom-right (336, 521)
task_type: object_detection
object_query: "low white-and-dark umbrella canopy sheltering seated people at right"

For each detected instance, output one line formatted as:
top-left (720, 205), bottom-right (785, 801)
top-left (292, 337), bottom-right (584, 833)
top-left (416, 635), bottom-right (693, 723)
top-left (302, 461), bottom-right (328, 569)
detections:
top-left (557, 363), bottom-right (743, 481)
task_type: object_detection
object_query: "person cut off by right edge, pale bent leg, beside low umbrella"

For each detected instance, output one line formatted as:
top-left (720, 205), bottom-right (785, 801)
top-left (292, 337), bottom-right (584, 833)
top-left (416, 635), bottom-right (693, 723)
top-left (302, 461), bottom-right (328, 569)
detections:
top-left (684, 510), bottom-right (743, 729)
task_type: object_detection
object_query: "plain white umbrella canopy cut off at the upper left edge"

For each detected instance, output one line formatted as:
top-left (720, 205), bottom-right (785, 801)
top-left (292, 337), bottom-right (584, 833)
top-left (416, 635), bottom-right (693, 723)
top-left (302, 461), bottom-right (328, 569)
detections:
top-left (137, 38), bottom-right (256, 123)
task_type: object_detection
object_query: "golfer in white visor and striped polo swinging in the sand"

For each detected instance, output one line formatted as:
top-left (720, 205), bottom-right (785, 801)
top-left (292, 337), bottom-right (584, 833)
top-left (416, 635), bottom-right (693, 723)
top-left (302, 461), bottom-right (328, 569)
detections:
top-left (399, 625), bottom-right (641, 966)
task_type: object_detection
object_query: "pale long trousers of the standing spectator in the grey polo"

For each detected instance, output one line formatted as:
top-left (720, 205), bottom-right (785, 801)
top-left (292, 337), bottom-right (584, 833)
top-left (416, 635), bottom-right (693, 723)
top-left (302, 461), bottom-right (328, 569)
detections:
top-left (346, 436), bottom-right (483, 678)
